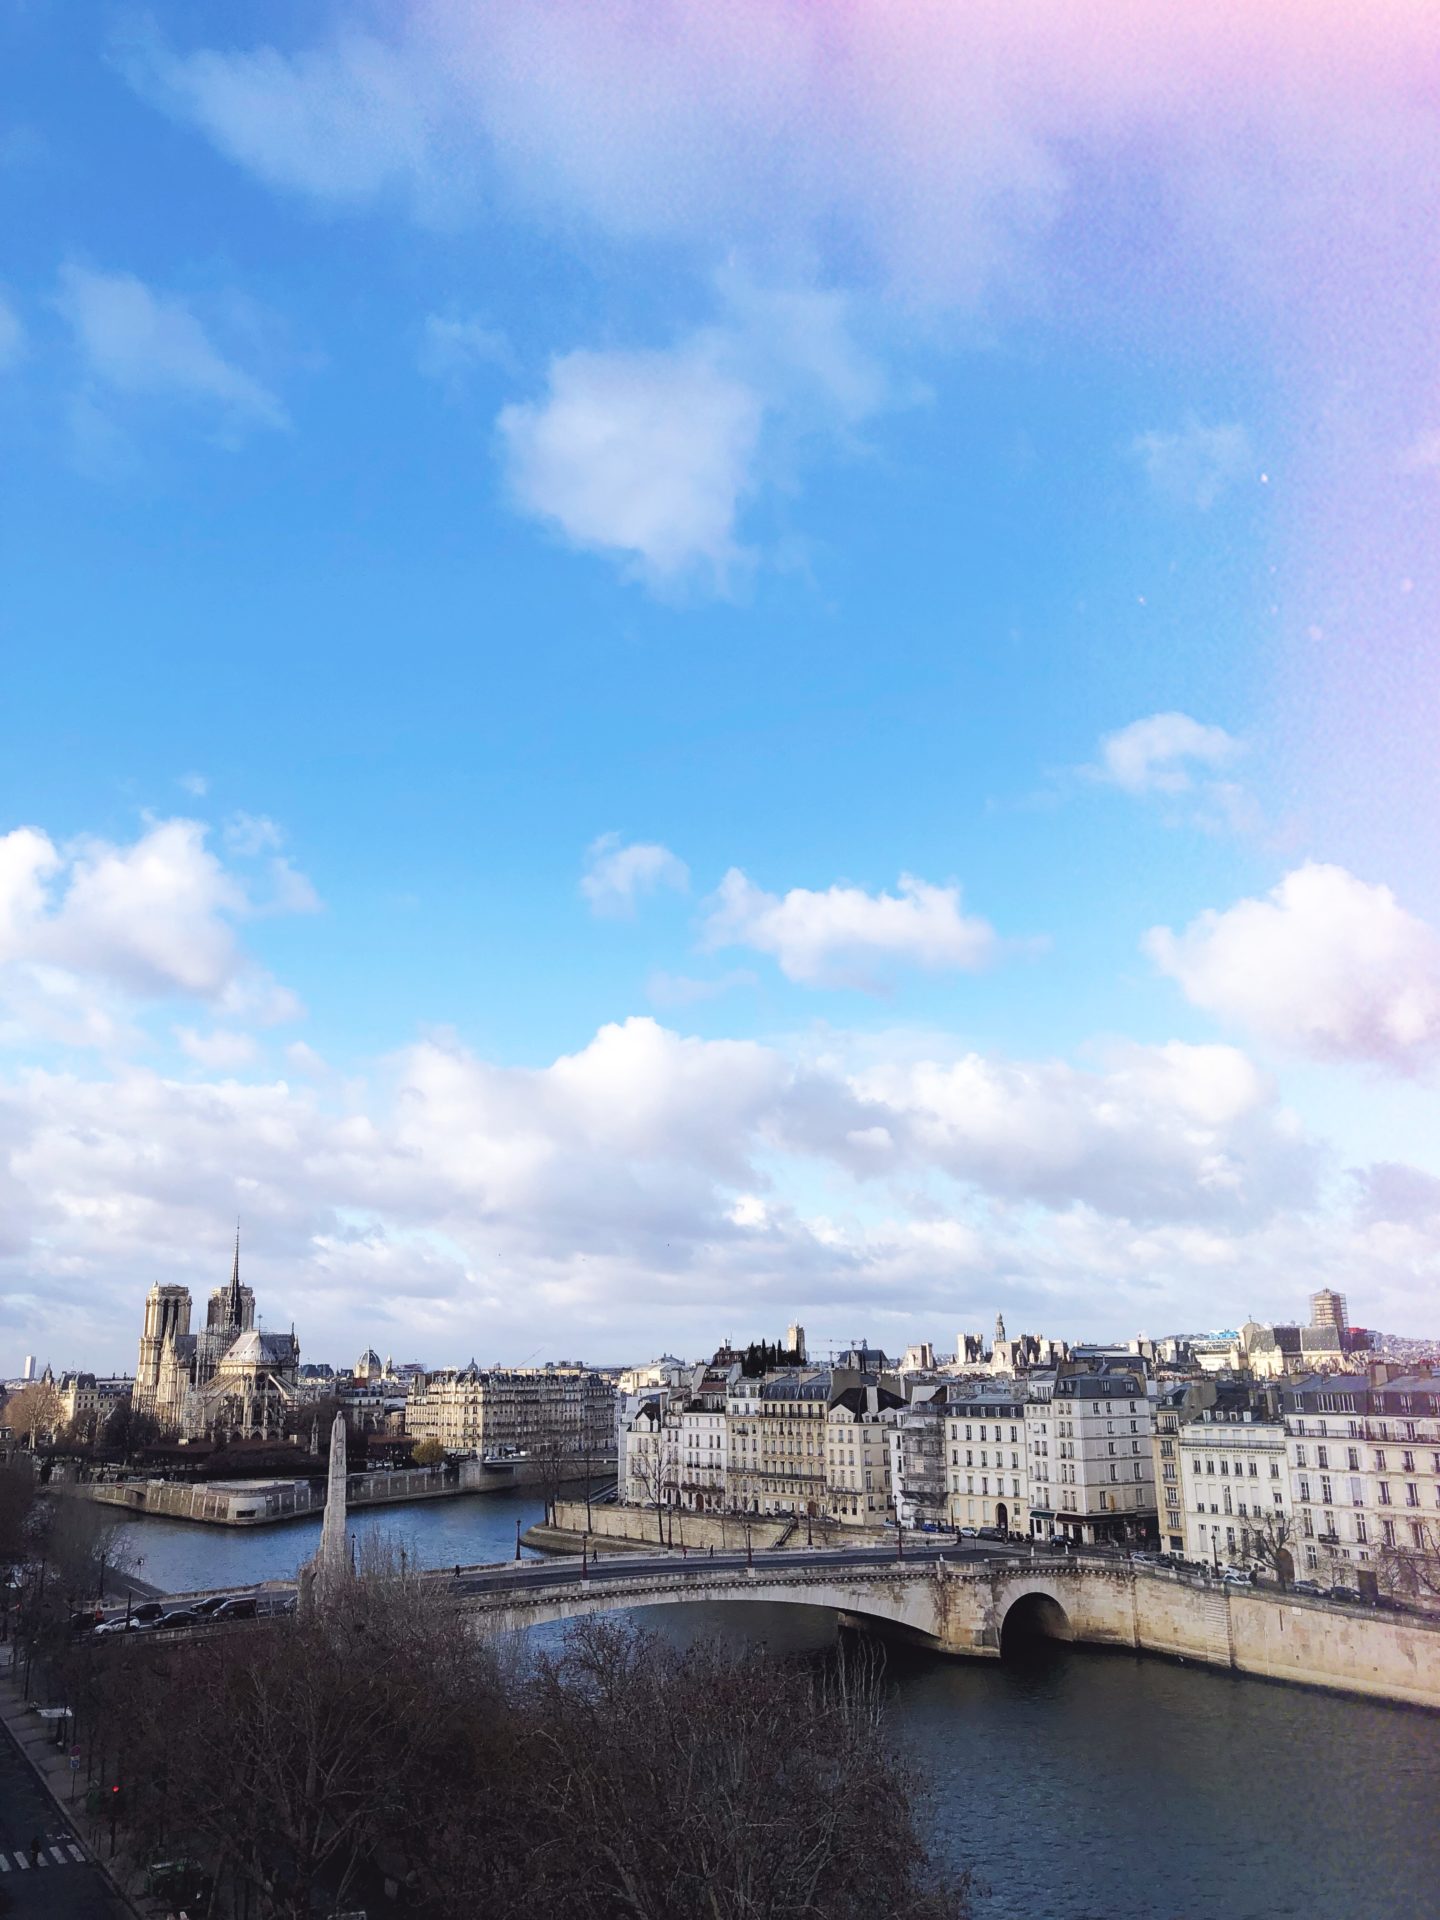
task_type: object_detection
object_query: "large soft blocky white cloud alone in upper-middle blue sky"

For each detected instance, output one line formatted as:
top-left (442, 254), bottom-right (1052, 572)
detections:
top-left (499, 336), bottom-right (762, 588)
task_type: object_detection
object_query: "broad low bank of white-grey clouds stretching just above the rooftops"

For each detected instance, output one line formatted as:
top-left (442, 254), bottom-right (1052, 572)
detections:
top-left (0, 1020), bottom-right (1397, 1361)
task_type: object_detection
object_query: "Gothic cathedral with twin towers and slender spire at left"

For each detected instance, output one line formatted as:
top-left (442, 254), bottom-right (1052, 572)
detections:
top-left (132, 1233), bottom-right (301, 1440)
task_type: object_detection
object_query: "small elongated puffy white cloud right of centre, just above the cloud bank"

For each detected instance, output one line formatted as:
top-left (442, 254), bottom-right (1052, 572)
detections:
top-left (703, 868), bottom-right (1000, 989)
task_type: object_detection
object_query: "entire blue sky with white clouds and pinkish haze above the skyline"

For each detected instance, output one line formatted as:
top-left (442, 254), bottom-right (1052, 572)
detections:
top-left (0, 0), bottom-right (1440, 1373)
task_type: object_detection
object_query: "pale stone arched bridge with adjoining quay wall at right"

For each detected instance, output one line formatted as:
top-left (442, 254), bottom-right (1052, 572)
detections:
top-left (463, 1553), bottom-right (1440, 1707)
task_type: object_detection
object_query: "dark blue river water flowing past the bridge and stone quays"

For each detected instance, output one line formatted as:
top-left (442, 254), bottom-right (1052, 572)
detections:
top-left (109, 1494), bottom-right (1440, 1920)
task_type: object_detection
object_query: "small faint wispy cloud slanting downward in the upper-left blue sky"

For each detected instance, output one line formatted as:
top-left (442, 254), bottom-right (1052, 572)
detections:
top-left (58, 261), bottom-right (290, 436)
